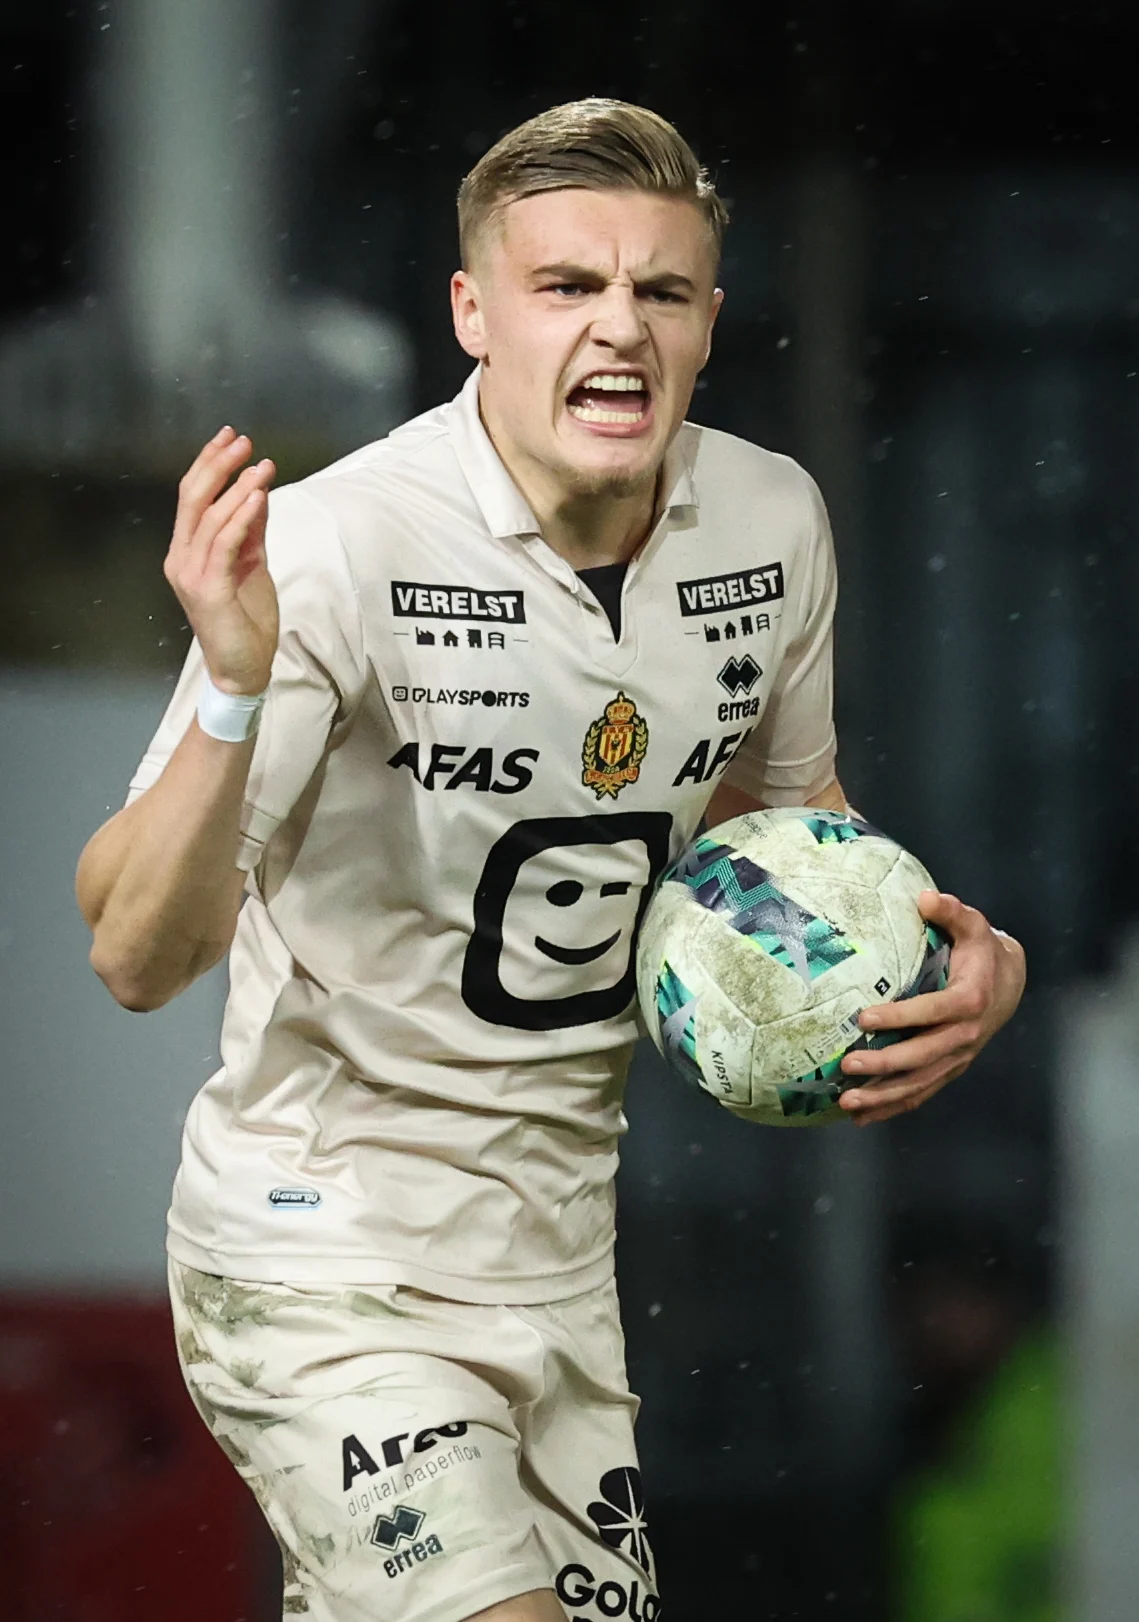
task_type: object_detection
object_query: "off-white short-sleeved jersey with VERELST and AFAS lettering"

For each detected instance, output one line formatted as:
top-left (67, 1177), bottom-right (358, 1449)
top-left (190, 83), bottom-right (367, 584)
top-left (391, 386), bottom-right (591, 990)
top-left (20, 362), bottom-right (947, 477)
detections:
top-left (131, 373), bottom-right (834, 1304)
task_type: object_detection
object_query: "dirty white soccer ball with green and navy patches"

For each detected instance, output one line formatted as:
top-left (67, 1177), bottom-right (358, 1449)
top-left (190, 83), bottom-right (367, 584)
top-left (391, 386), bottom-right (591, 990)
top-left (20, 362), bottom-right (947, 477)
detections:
top-left (636, 806), bottom-right (949, 1126)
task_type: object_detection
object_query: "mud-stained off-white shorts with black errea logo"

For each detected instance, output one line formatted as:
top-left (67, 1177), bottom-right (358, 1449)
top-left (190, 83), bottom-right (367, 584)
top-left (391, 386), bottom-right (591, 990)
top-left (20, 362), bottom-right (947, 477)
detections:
top-left (170, 1262), bottom-right (660, 1622)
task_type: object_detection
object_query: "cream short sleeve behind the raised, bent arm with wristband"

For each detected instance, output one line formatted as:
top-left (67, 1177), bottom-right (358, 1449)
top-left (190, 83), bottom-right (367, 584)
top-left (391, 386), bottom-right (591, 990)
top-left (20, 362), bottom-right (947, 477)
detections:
top-left (127, 485), bottom-right (367, 873)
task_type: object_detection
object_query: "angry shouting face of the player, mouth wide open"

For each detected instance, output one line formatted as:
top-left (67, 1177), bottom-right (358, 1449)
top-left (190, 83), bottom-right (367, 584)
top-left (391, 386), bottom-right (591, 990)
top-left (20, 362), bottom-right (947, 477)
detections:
top-left (453, 190), bottom-right (722, 495)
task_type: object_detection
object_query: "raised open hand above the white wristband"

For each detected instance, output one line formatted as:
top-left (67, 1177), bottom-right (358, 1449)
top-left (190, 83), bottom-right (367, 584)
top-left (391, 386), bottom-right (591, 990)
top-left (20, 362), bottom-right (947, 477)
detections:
top-left (164, 428), bottom-right (279, 694)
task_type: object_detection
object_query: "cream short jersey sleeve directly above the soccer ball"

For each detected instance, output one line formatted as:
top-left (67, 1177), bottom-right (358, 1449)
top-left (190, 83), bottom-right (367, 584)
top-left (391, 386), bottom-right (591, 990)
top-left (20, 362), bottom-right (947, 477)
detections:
top-left (725, 469), bottom-right (837, 806)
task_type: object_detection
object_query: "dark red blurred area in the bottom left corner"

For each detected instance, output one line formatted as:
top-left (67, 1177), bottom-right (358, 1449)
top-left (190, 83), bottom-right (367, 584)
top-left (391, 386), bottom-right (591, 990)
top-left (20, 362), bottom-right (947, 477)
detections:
top-left (0, 1298), bottom-right (268, 1622)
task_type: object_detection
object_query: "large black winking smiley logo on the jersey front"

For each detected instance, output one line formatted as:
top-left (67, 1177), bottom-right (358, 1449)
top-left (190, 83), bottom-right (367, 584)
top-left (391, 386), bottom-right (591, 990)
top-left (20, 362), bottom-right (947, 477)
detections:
top-left (462, 811), bottom-right (672, 1030)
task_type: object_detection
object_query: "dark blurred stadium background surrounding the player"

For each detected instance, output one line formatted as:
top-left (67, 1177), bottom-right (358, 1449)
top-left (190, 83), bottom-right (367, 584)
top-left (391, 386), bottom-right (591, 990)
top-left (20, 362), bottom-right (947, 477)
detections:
top-left (0, 0), bottom-right (1139, 1622)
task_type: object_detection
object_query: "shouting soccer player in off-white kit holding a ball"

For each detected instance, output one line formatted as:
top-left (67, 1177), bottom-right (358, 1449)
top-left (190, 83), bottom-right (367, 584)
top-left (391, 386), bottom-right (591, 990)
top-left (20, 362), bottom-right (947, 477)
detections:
top-left (78, 101), bottom-right (1024, 1622)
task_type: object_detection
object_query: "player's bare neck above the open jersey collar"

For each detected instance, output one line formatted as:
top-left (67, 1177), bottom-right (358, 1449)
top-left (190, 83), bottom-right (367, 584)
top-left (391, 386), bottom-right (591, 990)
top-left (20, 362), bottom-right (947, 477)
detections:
top-left (479, 389), bottom-right (660, 569)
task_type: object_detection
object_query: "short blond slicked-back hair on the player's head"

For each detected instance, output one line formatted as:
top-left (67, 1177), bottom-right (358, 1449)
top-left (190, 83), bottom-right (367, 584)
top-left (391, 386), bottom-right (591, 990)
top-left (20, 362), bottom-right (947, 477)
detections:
top-left (459, 96), bottom-right (729, 268)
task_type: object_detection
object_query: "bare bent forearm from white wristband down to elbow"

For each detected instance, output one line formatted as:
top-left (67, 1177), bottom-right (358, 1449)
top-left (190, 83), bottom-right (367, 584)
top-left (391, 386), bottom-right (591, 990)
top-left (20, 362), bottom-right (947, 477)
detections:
top-left (76, 722), bottom-right (253, 1011)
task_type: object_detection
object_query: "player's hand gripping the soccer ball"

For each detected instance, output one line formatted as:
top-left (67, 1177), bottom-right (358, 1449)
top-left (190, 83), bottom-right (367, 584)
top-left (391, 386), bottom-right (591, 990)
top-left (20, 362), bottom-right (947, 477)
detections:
top-left (839, 890), bottom-right (1024, 1126)
